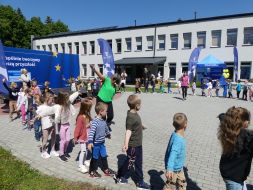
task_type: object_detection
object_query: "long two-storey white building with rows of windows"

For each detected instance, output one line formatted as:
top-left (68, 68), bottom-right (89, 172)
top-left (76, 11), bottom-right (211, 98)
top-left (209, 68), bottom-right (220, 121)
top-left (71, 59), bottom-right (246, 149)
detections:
top-left (32, 13), bottom-right (253, 82)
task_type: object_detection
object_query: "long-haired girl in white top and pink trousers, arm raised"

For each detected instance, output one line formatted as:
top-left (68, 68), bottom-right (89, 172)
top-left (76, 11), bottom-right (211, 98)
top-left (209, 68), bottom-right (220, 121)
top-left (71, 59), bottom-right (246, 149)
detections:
top-left (54, 92), bottom-right (79, 162)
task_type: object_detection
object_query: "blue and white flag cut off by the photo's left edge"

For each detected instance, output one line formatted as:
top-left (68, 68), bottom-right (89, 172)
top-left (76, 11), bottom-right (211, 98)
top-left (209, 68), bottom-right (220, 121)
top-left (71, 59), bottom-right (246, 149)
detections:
top-left (0, 40), bottom-right (8, 93)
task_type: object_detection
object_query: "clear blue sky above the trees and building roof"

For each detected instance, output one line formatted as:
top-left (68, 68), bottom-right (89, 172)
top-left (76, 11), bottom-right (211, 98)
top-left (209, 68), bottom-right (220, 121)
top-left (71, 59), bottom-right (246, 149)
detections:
top-left (0, 0), bottom-right (253, 31)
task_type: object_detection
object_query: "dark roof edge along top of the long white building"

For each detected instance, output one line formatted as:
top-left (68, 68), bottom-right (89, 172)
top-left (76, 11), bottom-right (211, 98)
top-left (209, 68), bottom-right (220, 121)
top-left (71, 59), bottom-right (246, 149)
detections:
top-left (33, 13), bottom-right (253, 40)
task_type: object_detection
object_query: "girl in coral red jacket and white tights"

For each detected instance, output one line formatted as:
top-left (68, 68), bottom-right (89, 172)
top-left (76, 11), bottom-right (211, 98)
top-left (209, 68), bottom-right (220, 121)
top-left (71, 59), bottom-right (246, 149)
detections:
top-left (74, 98), bottom-right (92, 173)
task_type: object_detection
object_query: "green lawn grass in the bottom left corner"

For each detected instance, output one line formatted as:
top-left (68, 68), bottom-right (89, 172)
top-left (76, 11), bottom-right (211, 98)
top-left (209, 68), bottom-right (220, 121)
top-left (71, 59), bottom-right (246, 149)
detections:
top-left (0, 147), bottom-right (105, 190)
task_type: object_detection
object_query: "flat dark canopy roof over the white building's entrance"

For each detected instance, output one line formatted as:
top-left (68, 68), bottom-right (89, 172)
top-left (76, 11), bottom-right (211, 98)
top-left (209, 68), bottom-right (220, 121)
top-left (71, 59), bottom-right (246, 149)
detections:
top-left (115, 57), bottom-right (166, 65)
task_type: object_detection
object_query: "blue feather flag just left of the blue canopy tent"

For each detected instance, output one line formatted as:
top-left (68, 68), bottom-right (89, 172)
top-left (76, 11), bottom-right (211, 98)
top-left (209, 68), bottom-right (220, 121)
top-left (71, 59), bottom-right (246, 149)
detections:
top-left (188, 47), bottom-right (201, 81)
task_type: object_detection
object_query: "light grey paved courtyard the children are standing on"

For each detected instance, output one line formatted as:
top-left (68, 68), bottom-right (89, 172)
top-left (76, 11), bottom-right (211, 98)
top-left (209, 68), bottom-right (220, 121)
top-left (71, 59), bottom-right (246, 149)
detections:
top-left (0, 93), bottom-right (253, 190)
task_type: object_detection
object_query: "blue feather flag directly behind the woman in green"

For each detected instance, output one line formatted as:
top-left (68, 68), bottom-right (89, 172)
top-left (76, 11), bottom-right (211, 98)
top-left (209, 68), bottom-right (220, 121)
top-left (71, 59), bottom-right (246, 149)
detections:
top-left (98, 38), bottom-right (115, 77)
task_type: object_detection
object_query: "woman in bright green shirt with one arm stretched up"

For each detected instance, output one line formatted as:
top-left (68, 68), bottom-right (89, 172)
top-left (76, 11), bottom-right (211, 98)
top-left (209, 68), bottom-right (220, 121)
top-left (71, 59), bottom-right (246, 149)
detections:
top-left (90, 65), bottom-right (120, 128)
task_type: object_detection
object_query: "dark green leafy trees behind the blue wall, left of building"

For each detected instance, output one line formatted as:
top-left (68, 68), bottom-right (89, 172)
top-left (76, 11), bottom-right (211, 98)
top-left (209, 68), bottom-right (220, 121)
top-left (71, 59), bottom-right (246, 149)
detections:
top-left (0, 5), bottom-right (69, 48)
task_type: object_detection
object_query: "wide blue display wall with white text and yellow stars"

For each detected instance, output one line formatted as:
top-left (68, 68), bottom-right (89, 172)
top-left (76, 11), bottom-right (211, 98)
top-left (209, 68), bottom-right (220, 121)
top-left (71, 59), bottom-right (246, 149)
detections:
top-left (0, 46), bottom-right (80, 91)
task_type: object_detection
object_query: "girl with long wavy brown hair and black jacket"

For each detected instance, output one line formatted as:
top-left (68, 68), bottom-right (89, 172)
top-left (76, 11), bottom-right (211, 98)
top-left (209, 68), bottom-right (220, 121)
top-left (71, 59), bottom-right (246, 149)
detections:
top-left (218, 107), bottom-right (253, 190)
